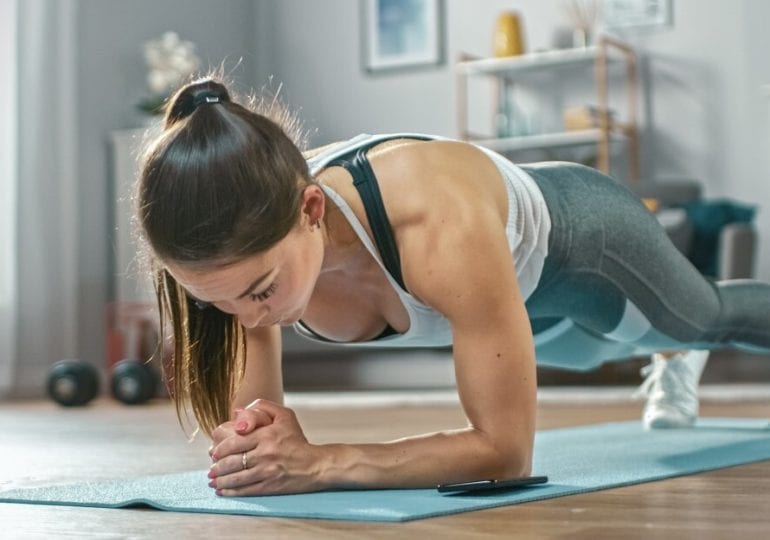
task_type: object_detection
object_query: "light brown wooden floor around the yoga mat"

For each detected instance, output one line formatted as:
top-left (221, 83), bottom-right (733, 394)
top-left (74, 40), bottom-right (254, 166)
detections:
top-left (0, 392), bottom-right (770, 540)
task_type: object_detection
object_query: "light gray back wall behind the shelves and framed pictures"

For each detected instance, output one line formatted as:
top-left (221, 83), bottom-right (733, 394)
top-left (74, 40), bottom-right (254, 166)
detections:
top-left (257, 0), bottom-right (770, 280)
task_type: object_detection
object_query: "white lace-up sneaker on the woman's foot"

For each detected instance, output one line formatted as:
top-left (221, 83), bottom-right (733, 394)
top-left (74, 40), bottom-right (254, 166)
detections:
top-left (636, 350), bottom-right (709, 429)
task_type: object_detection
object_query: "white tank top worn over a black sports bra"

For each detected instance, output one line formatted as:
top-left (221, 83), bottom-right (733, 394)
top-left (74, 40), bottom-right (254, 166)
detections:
top-left (294, 133), bottom-right (551, 347)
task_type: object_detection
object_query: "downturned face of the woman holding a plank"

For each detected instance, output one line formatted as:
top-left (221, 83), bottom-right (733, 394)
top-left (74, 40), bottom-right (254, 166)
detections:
top-left (167, 226), bottom-right (323, 328)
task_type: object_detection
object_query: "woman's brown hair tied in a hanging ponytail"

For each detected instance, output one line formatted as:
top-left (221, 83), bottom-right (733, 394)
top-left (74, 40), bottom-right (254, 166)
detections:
top-left (137, 78), bottom-right (311, 435)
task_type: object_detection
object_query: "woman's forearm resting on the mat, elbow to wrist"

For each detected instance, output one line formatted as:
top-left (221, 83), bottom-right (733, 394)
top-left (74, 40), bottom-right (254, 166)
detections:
top-left (317, 428), bottom-right (532, 489)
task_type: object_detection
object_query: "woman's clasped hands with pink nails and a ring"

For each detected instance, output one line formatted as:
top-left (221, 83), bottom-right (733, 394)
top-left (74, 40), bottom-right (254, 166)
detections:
top-left (209, 399), bottom-right (323, 497)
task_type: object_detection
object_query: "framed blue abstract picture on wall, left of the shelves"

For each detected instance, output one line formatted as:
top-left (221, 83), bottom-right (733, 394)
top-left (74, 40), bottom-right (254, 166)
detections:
top-left (361, 0), bottom-right (444, 73)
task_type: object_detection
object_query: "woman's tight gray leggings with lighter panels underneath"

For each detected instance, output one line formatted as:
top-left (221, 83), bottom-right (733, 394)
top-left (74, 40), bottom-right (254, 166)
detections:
top-left (522, 162), bottom-right (770, 370)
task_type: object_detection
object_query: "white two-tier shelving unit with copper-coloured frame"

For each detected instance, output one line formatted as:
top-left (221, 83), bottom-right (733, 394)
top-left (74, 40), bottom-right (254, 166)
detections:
top-left (455, 36), bottom-right (639, 181)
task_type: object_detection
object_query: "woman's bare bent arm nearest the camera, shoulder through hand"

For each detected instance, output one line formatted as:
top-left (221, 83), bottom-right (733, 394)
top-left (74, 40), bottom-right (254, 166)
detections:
top-left (207, 143), bottom-right (536, 495)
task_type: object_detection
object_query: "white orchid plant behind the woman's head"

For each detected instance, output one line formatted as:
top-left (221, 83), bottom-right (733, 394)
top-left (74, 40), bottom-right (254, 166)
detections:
top-left (138, 32), bottom-right (200, 115)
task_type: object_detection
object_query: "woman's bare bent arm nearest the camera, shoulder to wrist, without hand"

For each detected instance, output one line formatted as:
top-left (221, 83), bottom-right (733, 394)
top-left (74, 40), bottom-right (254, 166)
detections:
top-left (312, 188), bottom-right (537, 487)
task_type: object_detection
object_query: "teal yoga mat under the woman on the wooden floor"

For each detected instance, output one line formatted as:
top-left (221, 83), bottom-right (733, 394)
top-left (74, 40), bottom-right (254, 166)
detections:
top-left (0, 418), bottom-right (770, 521)
